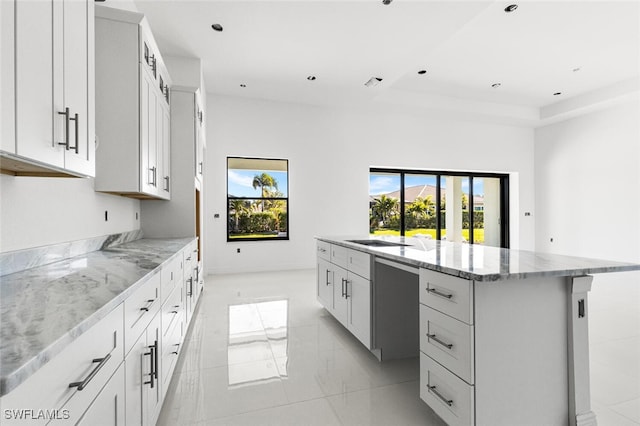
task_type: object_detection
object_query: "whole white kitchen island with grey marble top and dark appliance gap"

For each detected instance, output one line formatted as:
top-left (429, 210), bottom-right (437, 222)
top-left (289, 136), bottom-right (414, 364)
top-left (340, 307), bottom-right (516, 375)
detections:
top-left (317, 236), bottom-right (640, 425)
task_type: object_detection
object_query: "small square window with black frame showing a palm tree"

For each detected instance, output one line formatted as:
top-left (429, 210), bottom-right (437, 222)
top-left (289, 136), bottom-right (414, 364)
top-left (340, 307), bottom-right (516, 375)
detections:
top-left (227, 157), bottom-right (289, 241)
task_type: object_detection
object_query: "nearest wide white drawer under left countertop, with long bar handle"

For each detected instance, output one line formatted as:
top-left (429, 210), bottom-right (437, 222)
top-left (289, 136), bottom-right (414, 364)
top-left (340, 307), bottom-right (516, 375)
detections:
top-left (2, 304), bottom-right (124, 425)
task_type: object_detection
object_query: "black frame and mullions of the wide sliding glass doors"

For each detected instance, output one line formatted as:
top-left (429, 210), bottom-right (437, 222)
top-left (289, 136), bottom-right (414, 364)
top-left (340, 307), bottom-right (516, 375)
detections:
top-left (369, 167), bottom-right (510, 248)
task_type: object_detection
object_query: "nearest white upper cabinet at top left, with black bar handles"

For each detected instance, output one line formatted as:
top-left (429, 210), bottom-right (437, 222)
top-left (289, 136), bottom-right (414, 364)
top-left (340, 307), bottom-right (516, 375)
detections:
top-left (2, 0), bottom-right (95, 176)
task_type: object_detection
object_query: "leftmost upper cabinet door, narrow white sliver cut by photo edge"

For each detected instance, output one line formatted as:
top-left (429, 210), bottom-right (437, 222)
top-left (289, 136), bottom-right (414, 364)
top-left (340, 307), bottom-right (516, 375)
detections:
top-left (0, 0), bottom-right (16, 154)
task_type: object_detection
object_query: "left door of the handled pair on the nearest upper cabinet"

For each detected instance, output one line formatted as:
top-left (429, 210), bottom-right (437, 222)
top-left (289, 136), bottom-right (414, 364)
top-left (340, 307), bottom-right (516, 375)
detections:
top-left (14, 1), bottom-right (64, 167)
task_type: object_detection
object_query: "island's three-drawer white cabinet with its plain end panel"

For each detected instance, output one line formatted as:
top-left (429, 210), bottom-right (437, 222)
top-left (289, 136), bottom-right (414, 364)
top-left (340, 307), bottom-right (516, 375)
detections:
top-left (419, 269), bottom-right (570, 426)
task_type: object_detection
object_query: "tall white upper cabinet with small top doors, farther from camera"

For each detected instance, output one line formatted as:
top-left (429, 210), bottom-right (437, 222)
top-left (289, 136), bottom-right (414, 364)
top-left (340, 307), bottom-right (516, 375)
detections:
top-left (95, 6), bottom-right (171, 200)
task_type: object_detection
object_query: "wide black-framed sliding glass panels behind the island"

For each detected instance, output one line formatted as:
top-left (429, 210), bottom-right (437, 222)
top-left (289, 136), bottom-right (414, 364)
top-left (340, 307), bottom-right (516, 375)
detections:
top-left (369, 168), bottom-right (509, 247)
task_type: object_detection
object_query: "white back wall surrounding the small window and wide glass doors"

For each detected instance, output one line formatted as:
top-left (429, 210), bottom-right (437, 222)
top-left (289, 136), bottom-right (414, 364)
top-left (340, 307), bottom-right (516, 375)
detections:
top-left (204, 94), bottom-right (534, 273)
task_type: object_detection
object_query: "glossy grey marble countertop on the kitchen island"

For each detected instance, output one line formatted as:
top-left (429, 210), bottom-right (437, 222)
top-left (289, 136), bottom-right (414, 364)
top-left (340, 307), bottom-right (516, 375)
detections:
top-left (316, 235), bottom-right (640, 281)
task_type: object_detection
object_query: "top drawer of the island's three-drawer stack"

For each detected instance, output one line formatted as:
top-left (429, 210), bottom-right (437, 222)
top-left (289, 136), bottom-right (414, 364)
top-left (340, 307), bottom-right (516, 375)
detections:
top-left (420, 268), bottom-right (473, 324)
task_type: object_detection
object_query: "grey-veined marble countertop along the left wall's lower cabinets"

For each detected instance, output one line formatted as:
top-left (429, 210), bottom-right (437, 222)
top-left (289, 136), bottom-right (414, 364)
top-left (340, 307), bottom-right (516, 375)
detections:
top-left (0, 238), bottom-right (193, 396)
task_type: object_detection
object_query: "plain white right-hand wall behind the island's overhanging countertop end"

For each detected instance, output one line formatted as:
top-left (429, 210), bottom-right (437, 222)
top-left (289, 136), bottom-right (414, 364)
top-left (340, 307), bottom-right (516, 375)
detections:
top-left (535, 101), bottom-right (640, 264)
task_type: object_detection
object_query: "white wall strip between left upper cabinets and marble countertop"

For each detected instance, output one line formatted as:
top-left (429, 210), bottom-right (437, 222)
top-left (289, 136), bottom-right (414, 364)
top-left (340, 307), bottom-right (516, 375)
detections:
top-left (0, 175), bottom-right (140, 252)
